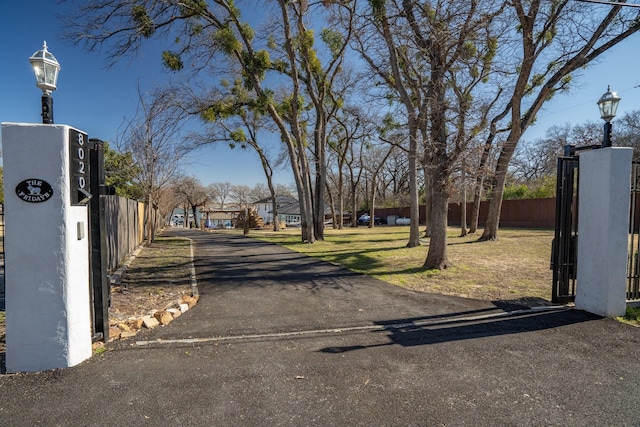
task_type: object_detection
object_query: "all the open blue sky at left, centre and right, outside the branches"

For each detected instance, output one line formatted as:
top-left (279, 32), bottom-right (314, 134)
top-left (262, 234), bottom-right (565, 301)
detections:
top-left (0, 0), bottom-right (640, 186)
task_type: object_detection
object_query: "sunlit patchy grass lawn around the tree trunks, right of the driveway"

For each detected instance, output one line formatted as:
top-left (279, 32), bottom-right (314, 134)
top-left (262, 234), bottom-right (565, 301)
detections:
top-left (232, 226), bottom-right (553, 302)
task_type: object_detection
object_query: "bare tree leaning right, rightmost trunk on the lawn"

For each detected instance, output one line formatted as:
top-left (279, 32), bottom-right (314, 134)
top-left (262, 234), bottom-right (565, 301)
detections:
top-left (480, 0), bottom-right (640, 240)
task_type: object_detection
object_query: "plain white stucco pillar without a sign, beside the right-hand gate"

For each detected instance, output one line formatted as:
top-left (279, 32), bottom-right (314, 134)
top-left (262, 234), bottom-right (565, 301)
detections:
top-left (575, 147), bottom-right (633, 317)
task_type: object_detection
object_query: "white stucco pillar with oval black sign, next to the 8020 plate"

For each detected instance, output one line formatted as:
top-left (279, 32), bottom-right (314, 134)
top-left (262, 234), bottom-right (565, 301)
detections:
top-left (2, 123), bottom-right (92, 372)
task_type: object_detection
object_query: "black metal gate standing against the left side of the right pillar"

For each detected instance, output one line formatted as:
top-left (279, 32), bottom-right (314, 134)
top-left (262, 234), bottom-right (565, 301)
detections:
top-left (551, 146), bottom-right (579, 303)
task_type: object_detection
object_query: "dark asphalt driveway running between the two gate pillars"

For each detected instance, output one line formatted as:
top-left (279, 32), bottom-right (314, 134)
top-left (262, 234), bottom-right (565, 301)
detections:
top-left (0, 230), bottom-right (640, 426)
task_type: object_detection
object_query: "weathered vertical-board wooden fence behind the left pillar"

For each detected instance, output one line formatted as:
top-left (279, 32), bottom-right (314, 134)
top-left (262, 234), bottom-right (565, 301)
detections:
top-left (103, 196), bottom-right (145, 272)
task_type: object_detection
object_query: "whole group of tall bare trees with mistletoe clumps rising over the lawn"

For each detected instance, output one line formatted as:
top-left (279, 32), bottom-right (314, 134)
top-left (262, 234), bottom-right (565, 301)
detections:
top-left (66, 0), bottom-right (640, 268)
